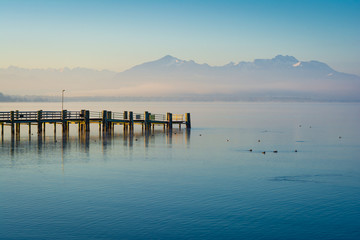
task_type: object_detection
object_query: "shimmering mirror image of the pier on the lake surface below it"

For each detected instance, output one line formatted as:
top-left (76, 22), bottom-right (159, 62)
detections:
top-left (0, 129), bottom-right (191, 168)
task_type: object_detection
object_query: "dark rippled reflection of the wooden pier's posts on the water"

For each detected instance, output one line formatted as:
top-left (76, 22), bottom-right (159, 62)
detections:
top-left (0, 129), bottom-right (191, 164)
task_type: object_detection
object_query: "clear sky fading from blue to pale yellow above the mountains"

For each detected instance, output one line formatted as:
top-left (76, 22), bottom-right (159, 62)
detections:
top-left (0, 0), bottom-right (360, 75)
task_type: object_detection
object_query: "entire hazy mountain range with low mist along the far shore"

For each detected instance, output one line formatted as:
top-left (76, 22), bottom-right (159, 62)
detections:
top-left (0, 55), bottom-right (360, 101)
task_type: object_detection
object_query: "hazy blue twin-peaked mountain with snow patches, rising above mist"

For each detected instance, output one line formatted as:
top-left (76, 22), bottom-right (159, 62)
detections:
top-left (113, 55), bottom-right (360, 100)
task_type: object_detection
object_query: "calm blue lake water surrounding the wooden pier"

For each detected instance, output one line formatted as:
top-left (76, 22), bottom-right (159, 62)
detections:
top-left (0, 102), bottom-right (360, 239)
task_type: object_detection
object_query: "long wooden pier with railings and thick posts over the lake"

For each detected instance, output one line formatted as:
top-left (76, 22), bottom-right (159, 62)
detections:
top-left (0, 110), bottom-right (191, 138)
